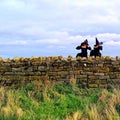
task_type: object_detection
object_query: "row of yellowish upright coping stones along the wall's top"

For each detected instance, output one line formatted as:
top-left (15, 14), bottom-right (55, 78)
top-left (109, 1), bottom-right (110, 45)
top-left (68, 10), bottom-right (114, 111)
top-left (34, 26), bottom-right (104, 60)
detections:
top-left (0, 56), bottom-right (120, 62)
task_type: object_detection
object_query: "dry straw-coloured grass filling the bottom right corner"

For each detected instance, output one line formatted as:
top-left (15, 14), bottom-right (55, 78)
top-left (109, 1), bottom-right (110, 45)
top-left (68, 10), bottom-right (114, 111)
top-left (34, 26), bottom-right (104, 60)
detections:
top-left (66, 89), bottom-right (120, 120)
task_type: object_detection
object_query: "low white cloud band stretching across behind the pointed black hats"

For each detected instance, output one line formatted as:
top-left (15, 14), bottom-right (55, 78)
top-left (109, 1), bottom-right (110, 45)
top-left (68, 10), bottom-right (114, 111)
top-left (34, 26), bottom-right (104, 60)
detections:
top-left (0, 31), bottom-right (120, 46)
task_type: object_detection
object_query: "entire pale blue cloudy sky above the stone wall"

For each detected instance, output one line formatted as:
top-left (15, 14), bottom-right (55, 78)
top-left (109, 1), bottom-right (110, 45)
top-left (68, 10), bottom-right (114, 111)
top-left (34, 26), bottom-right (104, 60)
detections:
top-left (0, 0), bottom-right (120, 58)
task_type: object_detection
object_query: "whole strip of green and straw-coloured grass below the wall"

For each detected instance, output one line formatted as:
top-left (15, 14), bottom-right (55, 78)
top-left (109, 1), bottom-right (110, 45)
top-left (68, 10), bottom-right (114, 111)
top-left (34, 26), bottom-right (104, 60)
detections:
top-left (0, 83), bottom-right (120, 120)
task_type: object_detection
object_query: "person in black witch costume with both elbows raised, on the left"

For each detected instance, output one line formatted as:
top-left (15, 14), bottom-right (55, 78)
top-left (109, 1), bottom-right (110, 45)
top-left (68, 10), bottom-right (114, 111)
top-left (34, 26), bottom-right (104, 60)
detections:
top-left (76, 39), bottom-right (91, 57)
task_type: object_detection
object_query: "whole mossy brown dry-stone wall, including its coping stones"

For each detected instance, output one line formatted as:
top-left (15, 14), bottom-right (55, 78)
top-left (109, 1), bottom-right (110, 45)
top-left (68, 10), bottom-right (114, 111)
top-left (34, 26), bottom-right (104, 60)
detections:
top-left (0, 56), bottom-right (120, 88)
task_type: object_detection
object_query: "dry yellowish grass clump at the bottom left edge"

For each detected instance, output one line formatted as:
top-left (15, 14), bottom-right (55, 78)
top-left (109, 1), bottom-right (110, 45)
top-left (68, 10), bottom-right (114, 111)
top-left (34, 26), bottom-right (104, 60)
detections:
top-left (0, 87), bottom-right (24, 118)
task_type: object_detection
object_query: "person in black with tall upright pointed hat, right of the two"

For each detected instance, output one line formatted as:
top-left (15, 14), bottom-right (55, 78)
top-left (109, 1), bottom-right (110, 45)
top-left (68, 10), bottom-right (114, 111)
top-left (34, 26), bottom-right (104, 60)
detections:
top-left (90, 38), bottom-right (103, 57)
